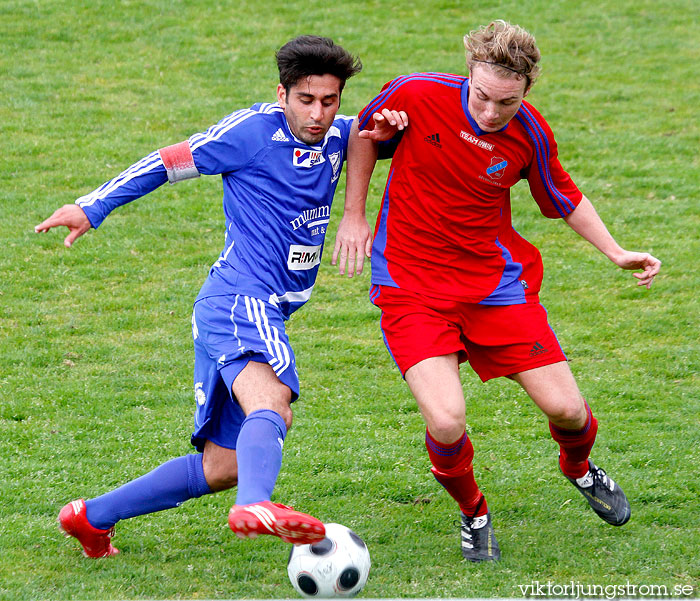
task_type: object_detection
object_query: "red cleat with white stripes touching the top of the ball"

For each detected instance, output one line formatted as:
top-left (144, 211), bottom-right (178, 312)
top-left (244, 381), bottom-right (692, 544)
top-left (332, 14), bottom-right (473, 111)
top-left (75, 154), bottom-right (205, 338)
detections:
top-left (228, 501), bottom-right (326, 545)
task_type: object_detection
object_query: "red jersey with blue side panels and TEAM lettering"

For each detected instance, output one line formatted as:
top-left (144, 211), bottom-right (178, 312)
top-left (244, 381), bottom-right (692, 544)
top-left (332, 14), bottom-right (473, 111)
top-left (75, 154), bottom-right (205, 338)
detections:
top-left (359, 73), bottom-right (582, 305)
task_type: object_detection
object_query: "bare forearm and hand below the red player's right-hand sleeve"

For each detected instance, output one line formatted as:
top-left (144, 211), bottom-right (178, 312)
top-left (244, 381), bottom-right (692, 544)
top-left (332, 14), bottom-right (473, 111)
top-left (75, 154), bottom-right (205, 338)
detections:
top-left (564, 196), bottom-right (661, 288)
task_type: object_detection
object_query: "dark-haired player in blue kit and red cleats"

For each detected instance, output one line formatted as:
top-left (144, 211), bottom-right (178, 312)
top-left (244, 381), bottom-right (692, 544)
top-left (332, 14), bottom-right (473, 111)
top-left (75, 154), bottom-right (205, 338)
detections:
top-left (35, 36), bottom-right (395, 557)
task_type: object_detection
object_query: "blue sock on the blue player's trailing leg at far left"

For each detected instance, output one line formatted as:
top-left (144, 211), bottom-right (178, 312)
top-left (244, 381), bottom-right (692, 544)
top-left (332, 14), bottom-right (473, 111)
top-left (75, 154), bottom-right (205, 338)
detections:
top-left (85, 454), bottom-right (211, 529)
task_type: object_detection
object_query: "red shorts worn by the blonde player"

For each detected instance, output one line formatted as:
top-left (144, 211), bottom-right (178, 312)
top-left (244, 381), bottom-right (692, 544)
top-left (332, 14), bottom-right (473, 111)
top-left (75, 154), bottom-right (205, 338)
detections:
top-left (370, 285), bottom-right (566, 382)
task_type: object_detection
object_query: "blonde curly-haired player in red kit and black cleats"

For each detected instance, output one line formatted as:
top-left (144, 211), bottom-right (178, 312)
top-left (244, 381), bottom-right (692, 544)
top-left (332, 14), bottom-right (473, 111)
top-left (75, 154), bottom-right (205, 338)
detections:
top-left (333, 21), bottom-right (661, 561)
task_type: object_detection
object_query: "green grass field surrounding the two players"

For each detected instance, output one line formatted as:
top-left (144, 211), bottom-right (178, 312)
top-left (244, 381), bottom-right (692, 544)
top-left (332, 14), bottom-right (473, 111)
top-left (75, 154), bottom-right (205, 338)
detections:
top-left (0, 0), bottom-right (700, 601)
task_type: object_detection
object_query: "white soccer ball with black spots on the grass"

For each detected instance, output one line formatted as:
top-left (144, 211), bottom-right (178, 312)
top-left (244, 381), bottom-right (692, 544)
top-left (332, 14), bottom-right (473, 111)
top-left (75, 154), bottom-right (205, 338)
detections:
top-left (287, 524), bottom-right (371, 598)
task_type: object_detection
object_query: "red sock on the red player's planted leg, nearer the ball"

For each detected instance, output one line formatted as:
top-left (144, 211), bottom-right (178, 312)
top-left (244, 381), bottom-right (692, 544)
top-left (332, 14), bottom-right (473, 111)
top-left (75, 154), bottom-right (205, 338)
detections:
top-left (425, 430), bottom-right (488, 517)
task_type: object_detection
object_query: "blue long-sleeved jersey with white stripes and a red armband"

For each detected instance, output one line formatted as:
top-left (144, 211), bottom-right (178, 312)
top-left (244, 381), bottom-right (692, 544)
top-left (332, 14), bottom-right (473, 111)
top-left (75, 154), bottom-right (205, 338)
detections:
top-left (76, 104), bottom-right (352, 316)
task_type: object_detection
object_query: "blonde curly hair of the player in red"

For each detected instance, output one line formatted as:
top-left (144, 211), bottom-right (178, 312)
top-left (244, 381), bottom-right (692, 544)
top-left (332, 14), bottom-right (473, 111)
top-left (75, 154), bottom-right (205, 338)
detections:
top-left (464, 19), bottom-right (541, 90)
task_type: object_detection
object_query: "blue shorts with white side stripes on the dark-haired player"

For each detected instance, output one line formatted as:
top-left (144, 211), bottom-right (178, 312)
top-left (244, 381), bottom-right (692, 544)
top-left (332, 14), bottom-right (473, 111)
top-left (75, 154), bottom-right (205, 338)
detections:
top-left (192, 294), bottom-right (299, 451)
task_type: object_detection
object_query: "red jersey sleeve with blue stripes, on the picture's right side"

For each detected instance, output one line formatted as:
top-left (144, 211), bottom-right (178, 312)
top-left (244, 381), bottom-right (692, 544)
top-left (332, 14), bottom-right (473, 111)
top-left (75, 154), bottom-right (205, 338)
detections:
top-left (517, 103), bottom-right (583, 219)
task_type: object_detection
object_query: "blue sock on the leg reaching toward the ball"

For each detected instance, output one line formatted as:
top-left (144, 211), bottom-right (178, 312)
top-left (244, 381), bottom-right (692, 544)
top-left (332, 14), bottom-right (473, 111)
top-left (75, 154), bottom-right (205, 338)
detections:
top-left (236, 409), bottom-right (287, 505)
